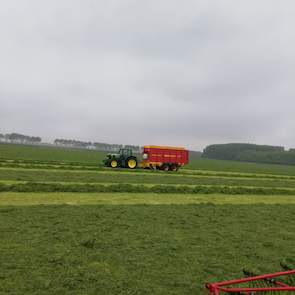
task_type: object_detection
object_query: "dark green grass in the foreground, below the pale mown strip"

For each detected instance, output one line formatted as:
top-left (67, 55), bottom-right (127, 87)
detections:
top-left (0, 204), bottom-right (295, 295)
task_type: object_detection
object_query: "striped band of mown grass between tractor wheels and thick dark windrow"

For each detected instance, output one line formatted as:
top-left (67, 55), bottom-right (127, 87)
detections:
top-left (0, 169), bottom-right (295, 188)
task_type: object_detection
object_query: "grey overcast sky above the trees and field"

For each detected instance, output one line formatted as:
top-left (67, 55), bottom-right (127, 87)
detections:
top-left (0, 0), bottom-right (295, 150)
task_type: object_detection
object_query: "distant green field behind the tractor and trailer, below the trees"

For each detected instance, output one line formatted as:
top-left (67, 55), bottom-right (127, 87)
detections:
top-left (0, 144), bottom-right (295, 176)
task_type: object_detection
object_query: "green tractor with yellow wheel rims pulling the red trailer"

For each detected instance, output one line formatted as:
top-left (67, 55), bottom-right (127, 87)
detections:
top-left (103, 148), bottom-right (138, 169)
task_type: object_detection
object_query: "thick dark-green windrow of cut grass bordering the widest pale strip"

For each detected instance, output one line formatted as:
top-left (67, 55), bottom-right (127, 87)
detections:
top-left (0, 182), bottom-right (295, 195)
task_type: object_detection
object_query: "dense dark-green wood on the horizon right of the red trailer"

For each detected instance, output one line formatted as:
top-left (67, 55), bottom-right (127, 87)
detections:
top-left (202, 143), bottom-right (295, 165)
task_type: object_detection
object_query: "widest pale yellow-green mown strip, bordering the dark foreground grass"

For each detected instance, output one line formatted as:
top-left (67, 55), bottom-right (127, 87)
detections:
top-left (0, 192), bottom-right (295, 207)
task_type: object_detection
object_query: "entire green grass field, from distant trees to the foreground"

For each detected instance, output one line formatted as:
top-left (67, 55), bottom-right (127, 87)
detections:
top-left (0, 144), bottom-right (295, 294)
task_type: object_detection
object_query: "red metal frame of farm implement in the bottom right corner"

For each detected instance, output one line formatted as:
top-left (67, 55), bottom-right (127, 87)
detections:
top-left (206, 270), bottom-right (295, 295)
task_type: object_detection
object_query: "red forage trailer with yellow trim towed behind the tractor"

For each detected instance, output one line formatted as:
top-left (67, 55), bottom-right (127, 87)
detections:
top-left (141, 145), bottom-right (189, 171)
